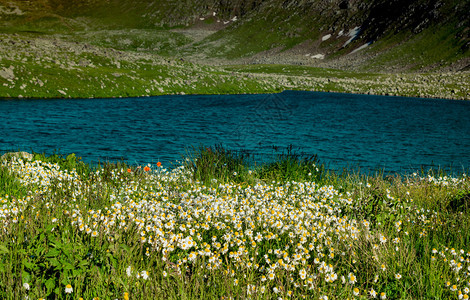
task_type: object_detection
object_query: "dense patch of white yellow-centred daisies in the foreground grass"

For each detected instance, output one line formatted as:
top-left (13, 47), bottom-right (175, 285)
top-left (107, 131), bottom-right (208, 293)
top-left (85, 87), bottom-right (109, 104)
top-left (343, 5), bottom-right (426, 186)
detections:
top-left (0, 159), bottom-right (470, 299)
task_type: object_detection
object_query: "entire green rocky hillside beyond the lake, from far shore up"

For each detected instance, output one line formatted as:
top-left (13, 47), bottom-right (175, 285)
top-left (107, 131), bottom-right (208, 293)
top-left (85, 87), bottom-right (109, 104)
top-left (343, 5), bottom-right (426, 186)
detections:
top-left (0, 0), bottom-right (470, 99)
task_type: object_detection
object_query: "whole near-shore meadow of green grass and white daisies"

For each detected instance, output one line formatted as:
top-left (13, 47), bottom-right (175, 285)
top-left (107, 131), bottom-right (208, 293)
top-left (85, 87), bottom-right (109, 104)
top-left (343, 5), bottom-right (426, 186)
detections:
top-left (0, 147), bottom-right (470, 300)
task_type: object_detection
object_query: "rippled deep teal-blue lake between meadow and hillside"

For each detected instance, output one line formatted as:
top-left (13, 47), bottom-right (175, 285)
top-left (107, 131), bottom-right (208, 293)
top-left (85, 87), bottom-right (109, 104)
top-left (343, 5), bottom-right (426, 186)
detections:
top-left (0, 91), bottom-right (470, 172)
